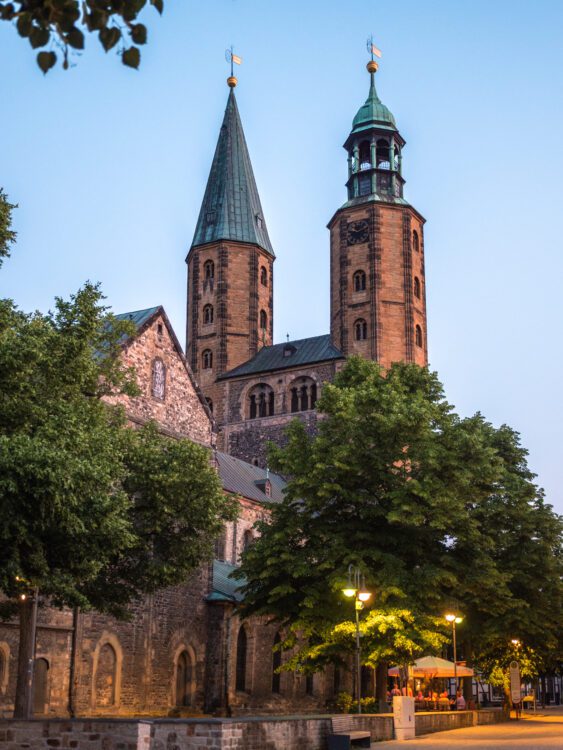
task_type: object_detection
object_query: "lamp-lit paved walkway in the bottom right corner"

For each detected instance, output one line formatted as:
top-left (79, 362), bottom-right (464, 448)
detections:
top-left (372, 708), bottom-right (563, 750)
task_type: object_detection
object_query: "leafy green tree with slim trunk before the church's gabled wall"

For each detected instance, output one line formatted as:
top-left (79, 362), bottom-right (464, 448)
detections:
top-left (0, 284), bottom-right (233, 716)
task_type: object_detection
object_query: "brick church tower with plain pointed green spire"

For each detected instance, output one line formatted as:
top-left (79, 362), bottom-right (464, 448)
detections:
top-left (186, 76), bottom-right (275, 420)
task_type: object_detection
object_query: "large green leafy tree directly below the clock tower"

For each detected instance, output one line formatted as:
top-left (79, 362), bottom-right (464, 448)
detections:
top-left (241, 357), bottom-right (494, 676)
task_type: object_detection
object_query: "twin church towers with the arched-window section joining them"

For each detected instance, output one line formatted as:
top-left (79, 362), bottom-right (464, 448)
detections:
top-left (186, 61), bottom-right (428, 466)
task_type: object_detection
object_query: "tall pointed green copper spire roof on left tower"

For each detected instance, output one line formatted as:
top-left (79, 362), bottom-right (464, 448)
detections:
top-left (192, 89), bottom-right (274, 256)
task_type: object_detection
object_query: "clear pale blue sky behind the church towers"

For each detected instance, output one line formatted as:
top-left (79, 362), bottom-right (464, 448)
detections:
top-left (0, 0), bottom-right (563, 512)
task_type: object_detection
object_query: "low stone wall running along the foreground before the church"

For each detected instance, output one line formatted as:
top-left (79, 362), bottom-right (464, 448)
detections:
top-left (0, 709), bottom-right (507, 750)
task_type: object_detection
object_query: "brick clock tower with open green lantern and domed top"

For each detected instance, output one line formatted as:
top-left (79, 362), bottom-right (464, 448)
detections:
top-left (328, 60), bottom-right (428, 367)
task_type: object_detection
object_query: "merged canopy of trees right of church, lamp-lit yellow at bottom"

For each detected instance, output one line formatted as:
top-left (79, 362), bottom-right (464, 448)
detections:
top-left (236, 357), bottom-right (562, 680)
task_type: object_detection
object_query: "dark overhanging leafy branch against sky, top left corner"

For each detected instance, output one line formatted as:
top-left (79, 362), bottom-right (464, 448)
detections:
top-left (0, 0), bottom-right (164, 73)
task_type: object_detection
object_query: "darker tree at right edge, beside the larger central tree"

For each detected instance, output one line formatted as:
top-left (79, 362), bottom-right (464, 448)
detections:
top-left (450, 420), bottom-right (563, 692)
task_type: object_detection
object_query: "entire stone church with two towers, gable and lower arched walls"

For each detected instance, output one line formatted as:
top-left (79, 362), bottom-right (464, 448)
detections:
top-left (0, 57), bottom-right (427, 716)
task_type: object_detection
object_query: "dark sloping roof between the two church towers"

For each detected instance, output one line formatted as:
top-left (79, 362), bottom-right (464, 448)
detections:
top-left (219, 333), bottom-right (344, 380)
